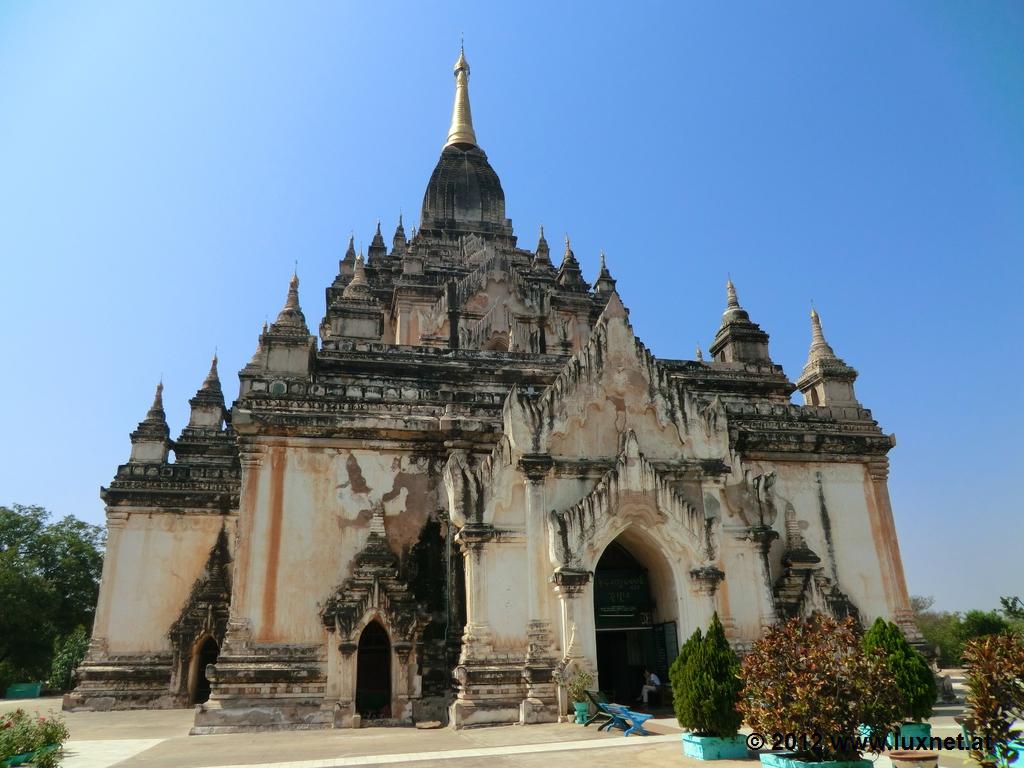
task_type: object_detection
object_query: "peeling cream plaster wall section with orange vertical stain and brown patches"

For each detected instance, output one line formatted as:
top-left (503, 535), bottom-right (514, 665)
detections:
top-left (236, 441), bottom-right (439, 643)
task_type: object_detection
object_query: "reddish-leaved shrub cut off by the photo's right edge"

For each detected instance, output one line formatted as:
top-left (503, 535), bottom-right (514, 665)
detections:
top-left (964, 634), bottom-right (1024, 768)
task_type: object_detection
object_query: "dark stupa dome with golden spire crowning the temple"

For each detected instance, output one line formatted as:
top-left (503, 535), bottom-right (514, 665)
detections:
top-left (420, 52), bottom-right (512, 238)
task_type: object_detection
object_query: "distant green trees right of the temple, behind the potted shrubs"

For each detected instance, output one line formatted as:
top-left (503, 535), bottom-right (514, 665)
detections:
top-left (910, 596), bottom-right (1024, 667)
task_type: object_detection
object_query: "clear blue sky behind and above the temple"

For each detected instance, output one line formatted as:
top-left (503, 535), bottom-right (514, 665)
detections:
top-left (0, 0), bottom-right (1024, 609)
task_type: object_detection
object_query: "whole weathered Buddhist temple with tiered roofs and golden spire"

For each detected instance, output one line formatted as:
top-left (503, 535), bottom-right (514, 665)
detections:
top-left (65, 48), bottom-right (919, 733)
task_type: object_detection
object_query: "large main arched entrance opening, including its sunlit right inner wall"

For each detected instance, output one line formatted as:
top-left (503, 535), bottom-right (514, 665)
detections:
top-left (594, 534), bottom-right (679, 703)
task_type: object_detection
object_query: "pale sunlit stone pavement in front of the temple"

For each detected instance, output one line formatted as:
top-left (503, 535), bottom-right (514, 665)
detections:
top-left (0, 671), bottom-right (969, 768)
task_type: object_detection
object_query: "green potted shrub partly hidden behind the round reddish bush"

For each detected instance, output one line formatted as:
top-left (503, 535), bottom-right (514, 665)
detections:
top-left (861, 618), bottom-right (938, 749)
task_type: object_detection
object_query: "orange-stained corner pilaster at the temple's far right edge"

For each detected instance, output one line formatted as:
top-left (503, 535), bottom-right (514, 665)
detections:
top-left (867, 457), bottom-right (924, 643)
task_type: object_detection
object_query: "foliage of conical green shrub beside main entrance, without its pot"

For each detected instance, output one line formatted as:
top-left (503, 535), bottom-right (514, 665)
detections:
top-left (673, 613), bottom-right (743, 738)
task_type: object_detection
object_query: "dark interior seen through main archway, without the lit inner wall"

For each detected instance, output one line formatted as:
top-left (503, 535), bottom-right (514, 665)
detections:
top-left (594, 541), bottom-right (667, 705)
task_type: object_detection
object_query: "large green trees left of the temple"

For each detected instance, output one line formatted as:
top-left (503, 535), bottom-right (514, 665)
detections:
top-left (0, 504), bottom-right (105, 696)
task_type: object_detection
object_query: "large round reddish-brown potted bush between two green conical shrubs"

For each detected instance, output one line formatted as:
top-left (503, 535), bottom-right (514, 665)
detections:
top-left (739, 614), bottom-right (903, 768)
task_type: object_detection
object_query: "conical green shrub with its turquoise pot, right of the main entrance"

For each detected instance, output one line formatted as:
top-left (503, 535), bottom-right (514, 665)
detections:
top-left (670, 613), bottom-right (746, 760)
